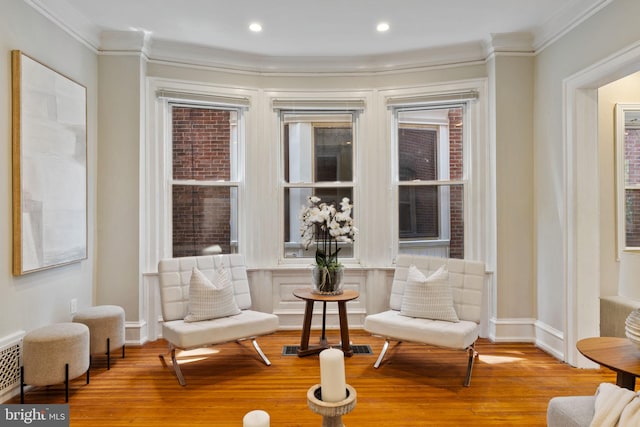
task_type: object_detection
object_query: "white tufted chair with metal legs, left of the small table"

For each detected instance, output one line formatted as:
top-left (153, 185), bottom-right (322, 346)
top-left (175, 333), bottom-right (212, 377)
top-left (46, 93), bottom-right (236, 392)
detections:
top-left (158, 254), bottom-right (279, 385)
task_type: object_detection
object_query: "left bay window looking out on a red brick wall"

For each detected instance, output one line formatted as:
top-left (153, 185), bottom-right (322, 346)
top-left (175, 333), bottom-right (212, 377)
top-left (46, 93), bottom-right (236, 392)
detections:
top-left (167, 100), bottom-right (243, 257)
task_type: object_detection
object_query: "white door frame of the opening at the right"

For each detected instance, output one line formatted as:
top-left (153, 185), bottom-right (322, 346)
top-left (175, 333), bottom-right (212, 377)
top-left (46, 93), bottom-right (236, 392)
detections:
top-left (563, 42), bottom-right (640, 367)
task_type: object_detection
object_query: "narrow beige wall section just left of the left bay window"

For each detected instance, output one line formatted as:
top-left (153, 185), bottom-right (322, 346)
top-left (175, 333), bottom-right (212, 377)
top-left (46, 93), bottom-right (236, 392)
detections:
top-left (96, 55), bottom-right (146, 341)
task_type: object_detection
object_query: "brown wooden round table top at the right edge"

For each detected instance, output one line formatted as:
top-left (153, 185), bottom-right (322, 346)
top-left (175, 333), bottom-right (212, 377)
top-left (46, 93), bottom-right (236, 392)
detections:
top-left (576, 337), bottom-right (640, 377)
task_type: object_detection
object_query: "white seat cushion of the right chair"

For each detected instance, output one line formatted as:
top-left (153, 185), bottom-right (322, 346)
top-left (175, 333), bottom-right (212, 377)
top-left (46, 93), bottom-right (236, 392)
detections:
top-left (364, 310), bottom-right (480, 350)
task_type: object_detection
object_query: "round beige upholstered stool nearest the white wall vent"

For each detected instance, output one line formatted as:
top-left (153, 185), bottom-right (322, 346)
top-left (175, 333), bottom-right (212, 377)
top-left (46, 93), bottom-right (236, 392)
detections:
top-left (20, 322), bottom-right (90, 403)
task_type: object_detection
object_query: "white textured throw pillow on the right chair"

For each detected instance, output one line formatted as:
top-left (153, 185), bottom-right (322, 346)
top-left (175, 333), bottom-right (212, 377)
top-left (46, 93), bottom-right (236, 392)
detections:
top-left (400, 265), bottom-right (460, 322)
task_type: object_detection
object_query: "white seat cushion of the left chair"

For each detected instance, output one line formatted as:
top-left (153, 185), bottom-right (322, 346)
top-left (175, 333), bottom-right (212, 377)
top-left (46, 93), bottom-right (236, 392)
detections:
top-left (162, 310), bottom-right (279, 348)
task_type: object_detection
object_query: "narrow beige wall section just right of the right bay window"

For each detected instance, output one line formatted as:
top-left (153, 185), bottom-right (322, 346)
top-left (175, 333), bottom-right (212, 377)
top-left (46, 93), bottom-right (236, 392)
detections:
top-left (493, 55), bottom-right (536, 334)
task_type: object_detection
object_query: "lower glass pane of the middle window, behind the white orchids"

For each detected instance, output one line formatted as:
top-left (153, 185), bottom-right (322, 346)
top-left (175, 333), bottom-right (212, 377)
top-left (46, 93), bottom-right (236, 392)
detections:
top-left (284, 187), bottom-right (356, 258)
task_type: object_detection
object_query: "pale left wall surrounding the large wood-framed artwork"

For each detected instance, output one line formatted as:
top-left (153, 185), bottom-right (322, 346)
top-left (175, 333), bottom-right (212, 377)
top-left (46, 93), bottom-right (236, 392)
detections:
top-left (0, 0), bottom-right (98, 342)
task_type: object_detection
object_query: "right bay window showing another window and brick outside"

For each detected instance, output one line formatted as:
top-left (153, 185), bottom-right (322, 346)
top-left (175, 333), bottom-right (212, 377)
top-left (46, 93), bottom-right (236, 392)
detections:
top-left (393, 102), bottom-right (466, 258)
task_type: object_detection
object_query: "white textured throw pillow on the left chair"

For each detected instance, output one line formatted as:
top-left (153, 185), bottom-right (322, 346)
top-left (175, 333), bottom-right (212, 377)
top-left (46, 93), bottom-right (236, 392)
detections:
top-left (184, 267), bottom-right (240, 322)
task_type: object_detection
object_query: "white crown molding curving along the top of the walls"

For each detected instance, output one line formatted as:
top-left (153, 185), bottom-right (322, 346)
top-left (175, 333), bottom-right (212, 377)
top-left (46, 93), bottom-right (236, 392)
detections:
top-left (23, 0), bottom-right (613, 74)
